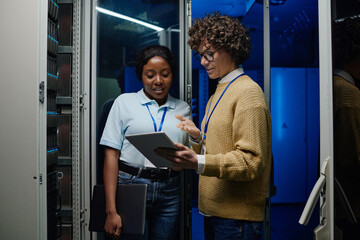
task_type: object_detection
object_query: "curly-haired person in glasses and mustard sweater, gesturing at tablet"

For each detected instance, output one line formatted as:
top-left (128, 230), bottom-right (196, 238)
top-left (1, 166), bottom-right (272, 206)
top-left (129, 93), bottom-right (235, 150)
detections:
top-left (156, 13), bottom-right (271, 240)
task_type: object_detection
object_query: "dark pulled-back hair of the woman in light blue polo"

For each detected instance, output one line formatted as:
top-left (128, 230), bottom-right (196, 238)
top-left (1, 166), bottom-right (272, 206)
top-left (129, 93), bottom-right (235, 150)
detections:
top-left (135, 45), bottom-right (177, 81)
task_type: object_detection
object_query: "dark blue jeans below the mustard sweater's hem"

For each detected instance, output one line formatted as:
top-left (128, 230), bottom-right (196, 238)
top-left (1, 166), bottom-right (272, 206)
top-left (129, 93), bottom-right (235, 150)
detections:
top-left (204, 216), bottom-right (262, 240)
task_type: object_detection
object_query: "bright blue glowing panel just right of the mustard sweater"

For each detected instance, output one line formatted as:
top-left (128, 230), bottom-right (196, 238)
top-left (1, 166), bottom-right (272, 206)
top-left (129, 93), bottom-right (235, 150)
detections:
top-left (271, 68), bottom-right (307, 203)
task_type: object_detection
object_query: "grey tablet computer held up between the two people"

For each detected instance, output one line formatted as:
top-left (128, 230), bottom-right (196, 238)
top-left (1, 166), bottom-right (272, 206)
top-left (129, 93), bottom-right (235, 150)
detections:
top-left (125, 132), bottom-right (176, 168)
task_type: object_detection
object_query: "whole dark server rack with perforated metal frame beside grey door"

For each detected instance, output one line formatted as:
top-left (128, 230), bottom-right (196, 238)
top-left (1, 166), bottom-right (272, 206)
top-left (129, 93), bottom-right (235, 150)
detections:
top-left (46, 0), bottom-right (87, 240)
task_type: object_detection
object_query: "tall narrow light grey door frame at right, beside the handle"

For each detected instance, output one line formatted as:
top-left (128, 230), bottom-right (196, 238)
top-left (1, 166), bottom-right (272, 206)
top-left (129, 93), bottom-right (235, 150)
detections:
top-left (314, 1), bottom-right (334, 240)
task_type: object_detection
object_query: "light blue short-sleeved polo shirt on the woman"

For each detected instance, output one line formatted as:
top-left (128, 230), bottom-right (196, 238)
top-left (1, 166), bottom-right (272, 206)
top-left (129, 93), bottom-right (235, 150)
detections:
top-left (100, 89), bottom-right (191, 167)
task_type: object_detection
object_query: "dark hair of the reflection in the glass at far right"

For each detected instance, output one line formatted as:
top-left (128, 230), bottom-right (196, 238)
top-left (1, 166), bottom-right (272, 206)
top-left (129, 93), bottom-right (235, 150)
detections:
top-left (332, 17), bottom-right (360, 69)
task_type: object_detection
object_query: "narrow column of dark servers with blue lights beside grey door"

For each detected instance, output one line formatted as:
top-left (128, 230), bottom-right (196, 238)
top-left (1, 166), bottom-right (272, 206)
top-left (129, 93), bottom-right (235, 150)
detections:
top-left (46, 0), bottom-right (61, 240)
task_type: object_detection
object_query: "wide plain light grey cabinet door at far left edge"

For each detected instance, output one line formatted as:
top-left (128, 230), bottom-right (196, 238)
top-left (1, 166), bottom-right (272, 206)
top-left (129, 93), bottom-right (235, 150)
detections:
top-left (0, 0), bottom-right (47, 239)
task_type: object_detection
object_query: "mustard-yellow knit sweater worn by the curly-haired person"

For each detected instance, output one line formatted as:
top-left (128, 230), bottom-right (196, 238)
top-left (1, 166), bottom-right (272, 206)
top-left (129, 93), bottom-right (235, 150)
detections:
top-left (192, 75), bottom-right (271, 221)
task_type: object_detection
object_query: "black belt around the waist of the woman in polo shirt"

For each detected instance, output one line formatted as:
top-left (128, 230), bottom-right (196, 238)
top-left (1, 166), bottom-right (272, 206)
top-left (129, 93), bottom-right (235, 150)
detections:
top-left (119, 161), bottom-right (179, 182)
